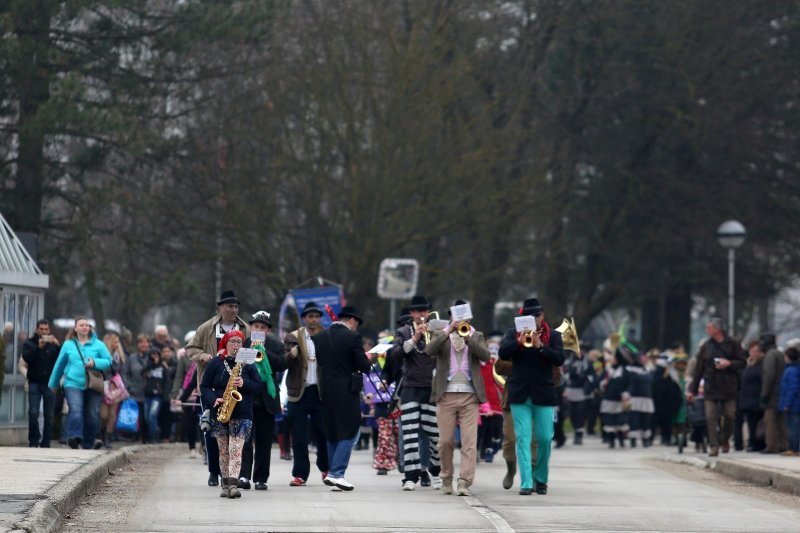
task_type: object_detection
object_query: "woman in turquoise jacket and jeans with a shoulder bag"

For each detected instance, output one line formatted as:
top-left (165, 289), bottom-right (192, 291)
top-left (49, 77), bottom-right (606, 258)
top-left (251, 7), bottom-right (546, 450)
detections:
top-left (48, 316), bottom-right (111, 449)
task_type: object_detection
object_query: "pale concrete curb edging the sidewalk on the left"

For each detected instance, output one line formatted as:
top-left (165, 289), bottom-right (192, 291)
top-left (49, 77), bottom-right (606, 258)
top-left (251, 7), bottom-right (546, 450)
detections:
top-left (12, 445), bottom-right (142, 533)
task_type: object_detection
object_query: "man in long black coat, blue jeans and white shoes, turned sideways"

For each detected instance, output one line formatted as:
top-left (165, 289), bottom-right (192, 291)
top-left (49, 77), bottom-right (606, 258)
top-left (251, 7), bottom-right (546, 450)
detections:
top-left (312, 305), bottom-right (370, 491)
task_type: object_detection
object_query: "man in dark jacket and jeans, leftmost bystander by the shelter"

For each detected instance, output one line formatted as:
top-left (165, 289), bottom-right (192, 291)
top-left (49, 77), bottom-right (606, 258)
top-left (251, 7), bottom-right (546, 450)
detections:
top-left (22, 318), bottom-right (60, 448)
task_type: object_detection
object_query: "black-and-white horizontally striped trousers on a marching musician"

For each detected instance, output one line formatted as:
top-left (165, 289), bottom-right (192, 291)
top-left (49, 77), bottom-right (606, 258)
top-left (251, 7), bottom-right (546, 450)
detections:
top-left (400, 401), bottom-right (441, 483)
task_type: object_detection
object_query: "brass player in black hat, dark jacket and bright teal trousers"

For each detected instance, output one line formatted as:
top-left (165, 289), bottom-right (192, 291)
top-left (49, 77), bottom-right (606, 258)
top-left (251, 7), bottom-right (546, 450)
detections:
top-left (500, 298), bottom-right (564, 496)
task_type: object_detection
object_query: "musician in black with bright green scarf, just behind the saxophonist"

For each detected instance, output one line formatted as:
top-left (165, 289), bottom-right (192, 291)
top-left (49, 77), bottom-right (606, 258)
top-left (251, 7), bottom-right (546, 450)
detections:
top-left (238, 311), bottom-right (286, 490)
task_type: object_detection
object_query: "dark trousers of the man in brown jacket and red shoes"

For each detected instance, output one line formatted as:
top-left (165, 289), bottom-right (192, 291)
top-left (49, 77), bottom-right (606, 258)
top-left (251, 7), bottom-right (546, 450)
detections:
top-left (286, 385), bottom-right (328, 479)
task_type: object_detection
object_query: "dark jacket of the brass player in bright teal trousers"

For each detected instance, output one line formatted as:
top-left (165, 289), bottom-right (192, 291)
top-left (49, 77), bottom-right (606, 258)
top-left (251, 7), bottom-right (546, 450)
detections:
top-left (499, 328), bottom-right (564, 405)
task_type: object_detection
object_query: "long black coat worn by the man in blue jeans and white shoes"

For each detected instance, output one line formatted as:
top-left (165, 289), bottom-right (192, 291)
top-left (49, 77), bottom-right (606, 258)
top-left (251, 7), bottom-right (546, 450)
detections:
top-left (311, 324), bottom-right (370, 442)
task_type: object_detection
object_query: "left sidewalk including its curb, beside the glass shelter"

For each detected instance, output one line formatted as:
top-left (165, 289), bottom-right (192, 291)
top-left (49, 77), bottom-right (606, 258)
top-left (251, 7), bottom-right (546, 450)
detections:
top-left (0, 446), bottom-right (138, 533)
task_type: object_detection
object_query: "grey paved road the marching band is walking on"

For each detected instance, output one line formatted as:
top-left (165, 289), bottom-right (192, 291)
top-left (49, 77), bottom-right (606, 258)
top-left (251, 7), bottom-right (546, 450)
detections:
top-left (65, 440), bottom-right (800, 532)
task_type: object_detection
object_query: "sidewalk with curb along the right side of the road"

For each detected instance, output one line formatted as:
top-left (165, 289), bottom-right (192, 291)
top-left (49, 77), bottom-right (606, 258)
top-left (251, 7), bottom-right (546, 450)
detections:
top-left (664, 444), bottom-right (800, 496)
